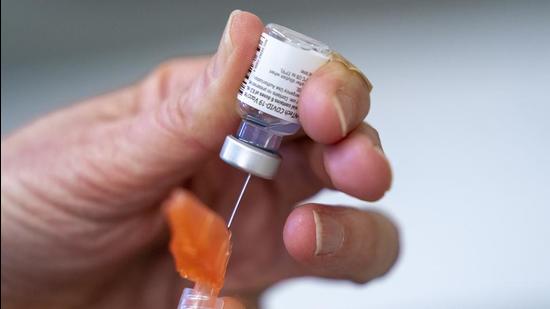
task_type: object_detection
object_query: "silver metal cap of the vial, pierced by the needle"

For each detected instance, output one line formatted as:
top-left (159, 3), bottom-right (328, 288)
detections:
top-left (220, 135), bottom-right (281, 179)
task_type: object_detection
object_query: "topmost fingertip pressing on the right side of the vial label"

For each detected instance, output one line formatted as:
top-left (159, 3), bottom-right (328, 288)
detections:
top-left (298, 62), bottom-right (370, 144)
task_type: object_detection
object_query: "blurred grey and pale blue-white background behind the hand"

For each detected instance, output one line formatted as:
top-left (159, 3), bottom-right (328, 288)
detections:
top-left (1, 0), bottom-right (550, 308)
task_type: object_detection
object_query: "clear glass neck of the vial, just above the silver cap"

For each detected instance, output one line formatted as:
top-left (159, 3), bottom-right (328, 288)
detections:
top-left (237, 119), bottom-right (283, 152)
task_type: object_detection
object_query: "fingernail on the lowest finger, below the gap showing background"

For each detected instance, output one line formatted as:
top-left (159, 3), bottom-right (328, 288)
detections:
top-left (313, 210), bottom-right (344, 256)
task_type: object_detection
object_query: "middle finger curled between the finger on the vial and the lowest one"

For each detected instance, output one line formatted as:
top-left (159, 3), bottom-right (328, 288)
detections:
top-left (273, 123), bottom-right (391, 205)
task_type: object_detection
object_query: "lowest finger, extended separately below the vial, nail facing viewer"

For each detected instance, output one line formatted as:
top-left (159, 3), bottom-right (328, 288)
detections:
top-left (283, 204), bottom-right (399, 283)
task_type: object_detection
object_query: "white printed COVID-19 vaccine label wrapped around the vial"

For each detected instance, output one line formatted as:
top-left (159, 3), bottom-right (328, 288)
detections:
top-left (237, 33), bottom-right (329, 123)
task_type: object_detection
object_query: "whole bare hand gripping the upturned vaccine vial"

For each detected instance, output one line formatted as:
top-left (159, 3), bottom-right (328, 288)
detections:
top-left (2, 11), bottom-right (398, 308)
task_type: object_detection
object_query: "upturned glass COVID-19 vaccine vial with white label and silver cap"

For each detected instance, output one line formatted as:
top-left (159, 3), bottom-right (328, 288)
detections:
top-left (220, 24), bottom-right (332, 179)
